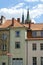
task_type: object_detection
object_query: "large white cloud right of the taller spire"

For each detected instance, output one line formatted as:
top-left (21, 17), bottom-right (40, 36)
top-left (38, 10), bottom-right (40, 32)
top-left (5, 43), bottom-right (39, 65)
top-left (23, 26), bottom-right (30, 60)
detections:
top-left (30, 4), bottom-right (43, 18)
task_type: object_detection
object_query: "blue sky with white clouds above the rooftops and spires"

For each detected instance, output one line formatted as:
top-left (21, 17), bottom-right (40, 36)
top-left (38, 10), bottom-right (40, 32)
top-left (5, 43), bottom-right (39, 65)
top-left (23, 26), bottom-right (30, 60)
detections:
top-left (0, 0), bottom-right (43, 23)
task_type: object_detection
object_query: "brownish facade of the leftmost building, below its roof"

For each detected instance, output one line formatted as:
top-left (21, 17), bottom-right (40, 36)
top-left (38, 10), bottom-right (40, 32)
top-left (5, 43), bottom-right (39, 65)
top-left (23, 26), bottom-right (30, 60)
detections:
top-left (0, 29), bottom-right (9, 65)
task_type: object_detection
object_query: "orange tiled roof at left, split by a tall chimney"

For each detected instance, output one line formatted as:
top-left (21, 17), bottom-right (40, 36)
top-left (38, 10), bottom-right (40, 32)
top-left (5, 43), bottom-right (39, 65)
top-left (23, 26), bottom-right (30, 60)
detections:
top-left (0, 20), bottom-right (23, 28)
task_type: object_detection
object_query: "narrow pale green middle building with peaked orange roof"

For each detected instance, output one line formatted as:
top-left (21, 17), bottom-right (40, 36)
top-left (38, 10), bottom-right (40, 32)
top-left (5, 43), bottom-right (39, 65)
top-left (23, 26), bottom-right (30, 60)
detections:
top-left (9, 20), bottom-right (27, 65)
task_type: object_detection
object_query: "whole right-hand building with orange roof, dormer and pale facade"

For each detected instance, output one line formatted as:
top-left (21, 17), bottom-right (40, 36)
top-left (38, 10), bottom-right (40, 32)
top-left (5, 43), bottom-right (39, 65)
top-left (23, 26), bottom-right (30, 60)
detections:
top-left (26, 23), bottom-right (43, 65)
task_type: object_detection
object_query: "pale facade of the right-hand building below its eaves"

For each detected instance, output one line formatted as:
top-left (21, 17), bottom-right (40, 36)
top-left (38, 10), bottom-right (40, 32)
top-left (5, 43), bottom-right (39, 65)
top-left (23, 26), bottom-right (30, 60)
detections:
top-left (28, 40), bottom-right (43, 65)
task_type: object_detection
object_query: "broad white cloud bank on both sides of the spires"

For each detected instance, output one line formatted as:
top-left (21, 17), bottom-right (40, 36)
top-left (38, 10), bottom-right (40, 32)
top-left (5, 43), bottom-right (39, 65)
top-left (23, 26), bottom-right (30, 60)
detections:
top-left (0, 3), bottom-right (43, 22)
